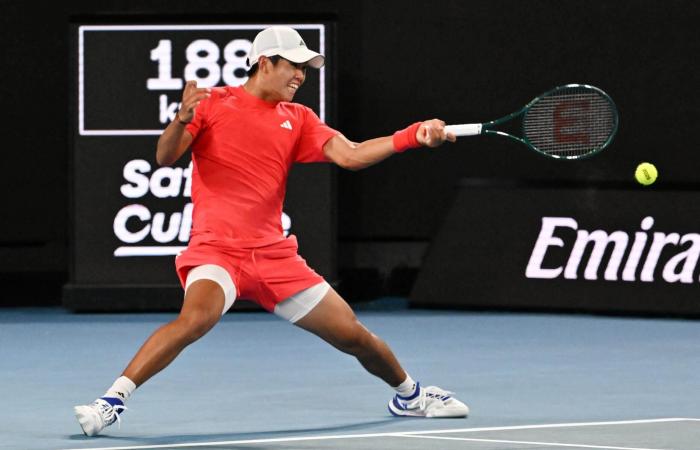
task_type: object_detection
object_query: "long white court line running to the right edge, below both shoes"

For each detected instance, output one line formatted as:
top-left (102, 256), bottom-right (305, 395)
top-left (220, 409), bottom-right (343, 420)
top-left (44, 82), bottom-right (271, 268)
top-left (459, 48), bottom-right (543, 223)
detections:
top-left (60, 418), bottom-right (700, 450)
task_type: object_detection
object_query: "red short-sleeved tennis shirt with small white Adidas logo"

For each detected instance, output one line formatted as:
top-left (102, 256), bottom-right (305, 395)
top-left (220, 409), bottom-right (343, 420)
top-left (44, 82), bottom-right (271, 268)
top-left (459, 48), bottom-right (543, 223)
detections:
top-left (187, 86), bottom-right (338, 245)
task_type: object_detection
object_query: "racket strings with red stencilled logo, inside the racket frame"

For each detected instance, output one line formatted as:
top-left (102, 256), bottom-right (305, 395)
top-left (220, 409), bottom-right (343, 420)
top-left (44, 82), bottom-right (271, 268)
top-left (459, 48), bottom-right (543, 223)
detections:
top-left (523, 86), bottom-right (616, 158)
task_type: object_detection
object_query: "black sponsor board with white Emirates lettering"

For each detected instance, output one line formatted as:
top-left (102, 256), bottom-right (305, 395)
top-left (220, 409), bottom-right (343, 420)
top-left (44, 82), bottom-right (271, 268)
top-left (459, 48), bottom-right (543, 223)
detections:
top-left (411, 183), bottom-right (700, 315)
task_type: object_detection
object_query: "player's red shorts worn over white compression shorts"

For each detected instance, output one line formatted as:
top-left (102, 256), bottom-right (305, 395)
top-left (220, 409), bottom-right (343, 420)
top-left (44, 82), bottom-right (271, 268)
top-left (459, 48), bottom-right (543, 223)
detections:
top-left (175, 235), bottom-right (323, 311)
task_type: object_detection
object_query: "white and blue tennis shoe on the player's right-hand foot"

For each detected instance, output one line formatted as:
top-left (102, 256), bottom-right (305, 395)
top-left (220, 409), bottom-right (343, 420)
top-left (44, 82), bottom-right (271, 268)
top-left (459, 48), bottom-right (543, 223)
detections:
top-left (389, 383), bottom-right (469, 418)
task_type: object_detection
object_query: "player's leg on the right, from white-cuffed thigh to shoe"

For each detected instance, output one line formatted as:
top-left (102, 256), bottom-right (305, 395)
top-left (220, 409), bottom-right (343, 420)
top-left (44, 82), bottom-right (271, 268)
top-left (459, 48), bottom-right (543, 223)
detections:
top-left (286, 287), bottom-right (469, 417)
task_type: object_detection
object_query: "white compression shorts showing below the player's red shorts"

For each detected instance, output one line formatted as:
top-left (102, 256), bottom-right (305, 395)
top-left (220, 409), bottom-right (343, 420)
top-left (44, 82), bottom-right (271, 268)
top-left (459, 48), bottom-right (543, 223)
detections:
top-left (185, 264), bottom-right (330, 323)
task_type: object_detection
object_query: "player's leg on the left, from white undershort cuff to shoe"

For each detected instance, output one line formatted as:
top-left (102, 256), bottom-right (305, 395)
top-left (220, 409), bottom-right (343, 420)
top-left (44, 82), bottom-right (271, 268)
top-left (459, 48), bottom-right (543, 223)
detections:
top-left (75, 265), bottom-right (235, 436)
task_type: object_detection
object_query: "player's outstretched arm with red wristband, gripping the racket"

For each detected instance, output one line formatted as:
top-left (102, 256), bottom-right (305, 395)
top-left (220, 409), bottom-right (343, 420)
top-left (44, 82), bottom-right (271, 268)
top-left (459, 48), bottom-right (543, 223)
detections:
top-left (323, 119), bottom-right (456, 170)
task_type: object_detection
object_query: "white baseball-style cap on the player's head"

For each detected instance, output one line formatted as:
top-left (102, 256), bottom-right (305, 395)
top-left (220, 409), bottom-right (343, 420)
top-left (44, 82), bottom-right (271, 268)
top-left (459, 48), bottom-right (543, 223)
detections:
top-left (246, 26), bottom-right (326, 69)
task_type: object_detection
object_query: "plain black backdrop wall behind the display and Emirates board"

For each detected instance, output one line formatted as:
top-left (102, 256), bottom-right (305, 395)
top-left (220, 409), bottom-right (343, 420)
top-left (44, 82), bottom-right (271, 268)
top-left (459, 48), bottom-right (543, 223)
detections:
top-left (0, 0), bottom-right (700, 305)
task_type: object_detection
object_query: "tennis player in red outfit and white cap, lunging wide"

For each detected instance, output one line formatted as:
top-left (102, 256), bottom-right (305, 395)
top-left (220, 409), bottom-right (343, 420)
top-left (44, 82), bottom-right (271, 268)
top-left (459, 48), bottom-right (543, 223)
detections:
top-left (75, 26), bottom-right (469, 436)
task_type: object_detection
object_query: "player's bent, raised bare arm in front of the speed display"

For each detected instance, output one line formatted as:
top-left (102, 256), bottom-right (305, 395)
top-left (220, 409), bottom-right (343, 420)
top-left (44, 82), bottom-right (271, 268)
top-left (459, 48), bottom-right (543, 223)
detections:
top-left (156, 81), bottom-right (211, 166)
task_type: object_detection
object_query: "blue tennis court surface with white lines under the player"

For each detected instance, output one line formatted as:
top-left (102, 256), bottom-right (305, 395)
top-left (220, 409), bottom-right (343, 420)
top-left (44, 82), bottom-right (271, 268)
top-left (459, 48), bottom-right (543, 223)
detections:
top-left (0, 302), bottom-right (700, 450)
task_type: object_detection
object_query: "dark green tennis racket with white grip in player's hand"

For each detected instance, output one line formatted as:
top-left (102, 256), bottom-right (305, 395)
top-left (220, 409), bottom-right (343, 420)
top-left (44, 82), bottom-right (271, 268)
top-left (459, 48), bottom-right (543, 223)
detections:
top-left (445, 84), bottom-right (619, 159)
